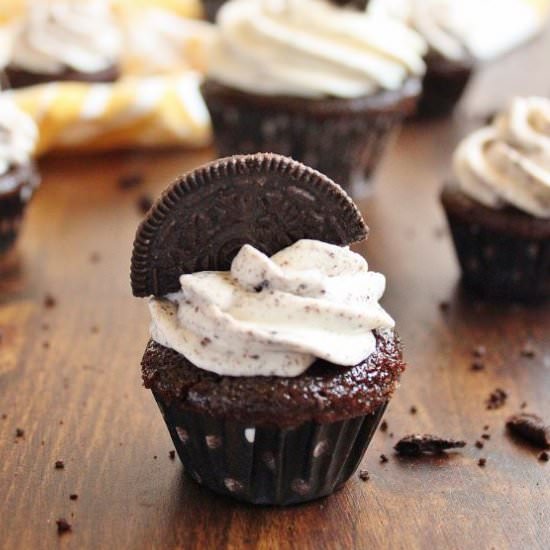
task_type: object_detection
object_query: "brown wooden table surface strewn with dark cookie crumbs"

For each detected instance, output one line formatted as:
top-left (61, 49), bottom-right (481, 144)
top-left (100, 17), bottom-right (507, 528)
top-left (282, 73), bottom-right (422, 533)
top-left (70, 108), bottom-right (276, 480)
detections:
top-left (0, 27), bottom-right (550, 550)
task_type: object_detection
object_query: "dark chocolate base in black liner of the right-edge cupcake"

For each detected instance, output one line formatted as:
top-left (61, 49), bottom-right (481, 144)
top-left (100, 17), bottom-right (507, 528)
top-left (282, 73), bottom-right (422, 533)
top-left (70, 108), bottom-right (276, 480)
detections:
top-left (443, 188), bottom-right (550, 302)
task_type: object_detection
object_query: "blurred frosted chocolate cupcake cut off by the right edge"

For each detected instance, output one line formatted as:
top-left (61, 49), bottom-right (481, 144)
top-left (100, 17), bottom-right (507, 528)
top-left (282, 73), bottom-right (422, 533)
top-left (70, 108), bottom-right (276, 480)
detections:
top-left (442, 97), bottom-right (550, 301)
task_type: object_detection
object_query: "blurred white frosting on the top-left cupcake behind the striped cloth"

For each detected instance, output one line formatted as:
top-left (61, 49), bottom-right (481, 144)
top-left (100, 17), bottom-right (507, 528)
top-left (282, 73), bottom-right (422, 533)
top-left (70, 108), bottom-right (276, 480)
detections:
top-left (11, 0), bottom-right (120, 75)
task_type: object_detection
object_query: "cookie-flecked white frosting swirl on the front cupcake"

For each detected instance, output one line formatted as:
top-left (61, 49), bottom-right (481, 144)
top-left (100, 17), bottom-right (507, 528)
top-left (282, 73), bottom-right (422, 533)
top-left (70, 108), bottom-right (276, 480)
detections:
top-left (149, 240), bottom-right (394, 376)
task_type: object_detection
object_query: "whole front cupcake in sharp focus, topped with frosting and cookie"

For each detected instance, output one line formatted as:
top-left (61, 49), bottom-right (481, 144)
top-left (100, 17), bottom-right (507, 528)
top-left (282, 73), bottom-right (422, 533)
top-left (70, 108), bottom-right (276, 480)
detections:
top-left (132, 154), bottom-right (405, 505)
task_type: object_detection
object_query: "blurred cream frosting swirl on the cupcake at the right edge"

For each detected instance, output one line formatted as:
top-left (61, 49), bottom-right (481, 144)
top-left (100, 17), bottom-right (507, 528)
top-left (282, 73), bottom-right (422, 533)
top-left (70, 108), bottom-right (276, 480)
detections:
top-left (453, 97), bottom-right (550, 218)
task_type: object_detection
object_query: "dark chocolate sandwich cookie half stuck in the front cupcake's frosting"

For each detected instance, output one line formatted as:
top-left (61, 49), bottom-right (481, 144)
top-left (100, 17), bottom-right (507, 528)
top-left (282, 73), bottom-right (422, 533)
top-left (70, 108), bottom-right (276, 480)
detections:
top-left (131, 153), bottom-right (368, 296)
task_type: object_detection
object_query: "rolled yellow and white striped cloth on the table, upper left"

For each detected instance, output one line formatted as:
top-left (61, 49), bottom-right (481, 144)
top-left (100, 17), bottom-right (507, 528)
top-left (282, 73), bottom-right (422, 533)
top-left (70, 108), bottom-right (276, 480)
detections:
top-left (8, 71), bottom-right (211, 155)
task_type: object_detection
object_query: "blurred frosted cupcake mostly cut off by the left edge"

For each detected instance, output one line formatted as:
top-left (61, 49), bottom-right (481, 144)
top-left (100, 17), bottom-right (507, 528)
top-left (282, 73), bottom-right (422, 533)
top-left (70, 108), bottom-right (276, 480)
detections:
top-left (0, 97), bottom-right (39, 255)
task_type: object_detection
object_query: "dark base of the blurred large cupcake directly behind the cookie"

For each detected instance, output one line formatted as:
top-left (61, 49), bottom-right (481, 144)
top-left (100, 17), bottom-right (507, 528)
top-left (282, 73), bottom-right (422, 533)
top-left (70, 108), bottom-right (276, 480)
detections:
top-left (203, 79), bottom-right (420, 197)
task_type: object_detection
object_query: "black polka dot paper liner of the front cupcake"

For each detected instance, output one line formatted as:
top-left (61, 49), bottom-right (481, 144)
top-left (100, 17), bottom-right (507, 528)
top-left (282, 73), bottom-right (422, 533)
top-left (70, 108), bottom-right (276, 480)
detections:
top-left (155, 395), bottom-right (387, 506)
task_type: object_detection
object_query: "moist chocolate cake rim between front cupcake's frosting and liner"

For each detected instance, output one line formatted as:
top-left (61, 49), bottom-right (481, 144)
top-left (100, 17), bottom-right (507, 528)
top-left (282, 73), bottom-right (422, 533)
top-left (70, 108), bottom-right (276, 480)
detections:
top-left (142, 331), bottom-right (405, 427)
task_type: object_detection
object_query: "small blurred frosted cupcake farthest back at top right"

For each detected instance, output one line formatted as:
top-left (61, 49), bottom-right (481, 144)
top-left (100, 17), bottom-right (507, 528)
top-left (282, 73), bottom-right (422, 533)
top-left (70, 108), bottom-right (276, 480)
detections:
top-left (369, 0), bottom-right (479, 118)
